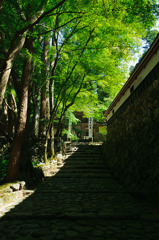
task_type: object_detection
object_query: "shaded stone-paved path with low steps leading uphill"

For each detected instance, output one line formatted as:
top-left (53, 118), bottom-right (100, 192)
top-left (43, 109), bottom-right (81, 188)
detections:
top-left (0, 145), bottom-right (159, 240)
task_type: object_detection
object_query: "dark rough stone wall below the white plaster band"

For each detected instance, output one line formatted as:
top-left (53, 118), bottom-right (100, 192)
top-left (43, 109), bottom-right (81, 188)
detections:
top-left (103, 69), bottom-right (159, 198)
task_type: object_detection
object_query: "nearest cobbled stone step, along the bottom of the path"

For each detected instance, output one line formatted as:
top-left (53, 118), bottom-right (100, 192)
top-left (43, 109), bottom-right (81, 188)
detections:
top-left (0, 215), bottom-right (159, 240)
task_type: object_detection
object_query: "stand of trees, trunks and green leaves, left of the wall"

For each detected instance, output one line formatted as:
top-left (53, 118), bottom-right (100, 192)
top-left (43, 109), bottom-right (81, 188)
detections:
top-left (0, 0), bottom-right (158, 184)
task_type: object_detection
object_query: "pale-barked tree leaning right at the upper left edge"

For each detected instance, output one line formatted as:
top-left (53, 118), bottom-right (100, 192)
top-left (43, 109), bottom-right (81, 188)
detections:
top-left (0, 0), bottom-right (66, 108)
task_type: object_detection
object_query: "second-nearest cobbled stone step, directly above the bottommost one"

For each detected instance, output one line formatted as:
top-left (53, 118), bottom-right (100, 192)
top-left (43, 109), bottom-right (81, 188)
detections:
top-left (5, 191), bottom-right (146, 219)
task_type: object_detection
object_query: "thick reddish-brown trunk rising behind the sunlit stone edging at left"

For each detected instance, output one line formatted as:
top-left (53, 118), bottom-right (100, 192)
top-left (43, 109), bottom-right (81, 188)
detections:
top-left (6, 35), bottom-right (33, 182)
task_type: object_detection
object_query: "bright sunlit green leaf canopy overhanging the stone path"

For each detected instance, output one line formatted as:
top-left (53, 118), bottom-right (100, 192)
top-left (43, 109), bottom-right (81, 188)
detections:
top-left (0, 0), bottom-right (158, 139)
